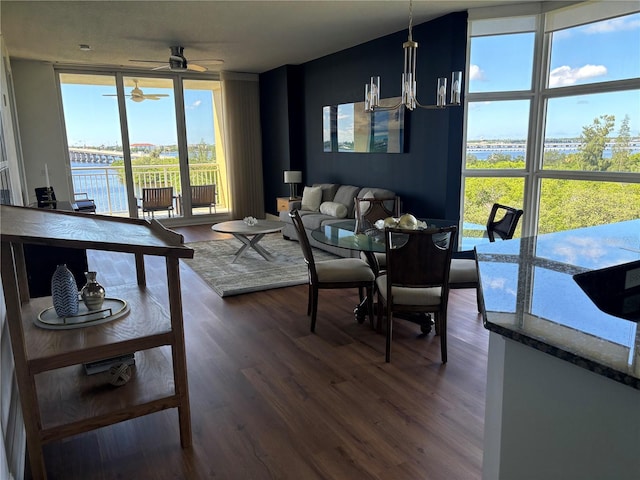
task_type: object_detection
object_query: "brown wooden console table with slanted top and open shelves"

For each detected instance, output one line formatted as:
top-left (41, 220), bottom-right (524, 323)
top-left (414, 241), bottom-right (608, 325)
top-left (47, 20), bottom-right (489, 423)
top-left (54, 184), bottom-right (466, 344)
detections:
top-left (0, 205), bottom-right (193, 479)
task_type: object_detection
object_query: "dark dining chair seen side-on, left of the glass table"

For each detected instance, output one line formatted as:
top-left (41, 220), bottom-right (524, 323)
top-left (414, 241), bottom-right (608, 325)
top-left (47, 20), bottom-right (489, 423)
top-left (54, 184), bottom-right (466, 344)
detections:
top-left (289, 210), bottom-right (376, 332)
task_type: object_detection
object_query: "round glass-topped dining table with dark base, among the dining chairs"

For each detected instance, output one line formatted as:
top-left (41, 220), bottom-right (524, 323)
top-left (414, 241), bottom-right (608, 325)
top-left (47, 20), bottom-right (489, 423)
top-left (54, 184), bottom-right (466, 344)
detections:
top-left (311, 218), bottom-right (457, 333)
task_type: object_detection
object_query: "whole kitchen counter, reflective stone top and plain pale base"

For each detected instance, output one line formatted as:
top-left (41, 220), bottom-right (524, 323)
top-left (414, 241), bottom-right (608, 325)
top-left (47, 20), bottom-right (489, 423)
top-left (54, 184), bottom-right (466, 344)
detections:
top-left (476, 220), bottom-right (640, 480)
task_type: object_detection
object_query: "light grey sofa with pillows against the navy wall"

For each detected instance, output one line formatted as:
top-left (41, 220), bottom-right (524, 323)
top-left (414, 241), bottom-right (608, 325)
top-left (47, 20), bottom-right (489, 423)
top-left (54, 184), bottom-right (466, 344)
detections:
top-left (280, 183), bottom-right (401, 257)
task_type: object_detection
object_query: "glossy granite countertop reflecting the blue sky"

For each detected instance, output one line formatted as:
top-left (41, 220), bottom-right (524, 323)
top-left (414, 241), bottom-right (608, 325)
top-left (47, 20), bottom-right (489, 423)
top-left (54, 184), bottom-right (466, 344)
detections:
top-left (476, 220), bottom-right (640, 389)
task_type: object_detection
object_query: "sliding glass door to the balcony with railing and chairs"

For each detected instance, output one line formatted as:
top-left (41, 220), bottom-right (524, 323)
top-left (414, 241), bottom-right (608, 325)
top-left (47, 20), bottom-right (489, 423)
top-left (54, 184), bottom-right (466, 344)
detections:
top-left (58, 71), bottom-right (228, 219)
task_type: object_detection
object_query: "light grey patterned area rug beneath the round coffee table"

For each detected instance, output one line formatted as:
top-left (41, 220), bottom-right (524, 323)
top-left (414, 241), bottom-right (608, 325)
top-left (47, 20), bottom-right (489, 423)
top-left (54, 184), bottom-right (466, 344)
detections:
top-left (185, 233), bottom-right (338, 297)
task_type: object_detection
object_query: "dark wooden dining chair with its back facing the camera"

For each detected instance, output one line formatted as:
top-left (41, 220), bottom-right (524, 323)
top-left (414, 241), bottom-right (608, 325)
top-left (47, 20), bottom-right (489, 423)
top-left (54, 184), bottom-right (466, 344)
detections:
top-left (376, 225), bottom-right (457, 363)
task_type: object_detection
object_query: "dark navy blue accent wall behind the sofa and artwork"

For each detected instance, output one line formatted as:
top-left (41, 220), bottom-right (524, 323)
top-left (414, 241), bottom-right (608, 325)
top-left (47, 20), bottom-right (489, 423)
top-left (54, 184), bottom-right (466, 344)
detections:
top-left (260, 12), bottom-right (467, 220)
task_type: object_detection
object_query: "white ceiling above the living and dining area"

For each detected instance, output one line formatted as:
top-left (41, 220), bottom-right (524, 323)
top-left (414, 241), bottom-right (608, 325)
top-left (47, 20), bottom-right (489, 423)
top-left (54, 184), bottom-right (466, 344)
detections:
top-left (0, 0), bottom-right (536, 73)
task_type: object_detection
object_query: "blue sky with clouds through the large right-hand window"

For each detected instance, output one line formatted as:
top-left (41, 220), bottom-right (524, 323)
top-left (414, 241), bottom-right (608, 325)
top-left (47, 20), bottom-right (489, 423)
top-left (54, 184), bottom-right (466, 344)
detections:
top-left (467, 14), bottom-right (640, 140)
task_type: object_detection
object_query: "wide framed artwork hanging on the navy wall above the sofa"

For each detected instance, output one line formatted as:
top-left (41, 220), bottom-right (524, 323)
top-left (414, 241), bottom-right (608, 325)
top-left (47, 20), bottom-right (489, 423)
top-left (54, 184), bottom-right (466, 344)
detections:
top-left (322, 97), bottom-right (405, 153)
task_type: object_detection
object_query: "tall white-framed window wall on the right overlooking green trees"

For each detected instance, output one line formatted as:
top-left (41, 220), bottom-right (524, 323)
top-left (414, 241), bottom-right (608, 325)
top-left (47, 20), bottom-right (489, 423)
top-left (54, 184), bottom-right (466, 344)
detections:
top-left (461, 2), bottom-right (640, 244)
